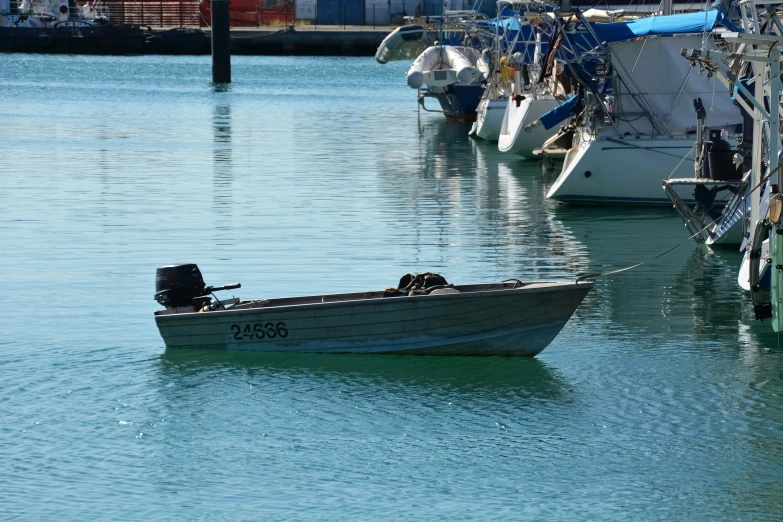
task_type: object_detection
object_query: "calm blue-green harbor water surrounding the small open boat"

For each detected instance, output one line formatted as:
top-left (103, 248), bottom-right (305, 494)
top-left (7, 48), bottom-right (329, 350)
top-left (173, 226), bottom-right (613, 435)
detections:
top-left (0, 55), bottom-right (783, 520)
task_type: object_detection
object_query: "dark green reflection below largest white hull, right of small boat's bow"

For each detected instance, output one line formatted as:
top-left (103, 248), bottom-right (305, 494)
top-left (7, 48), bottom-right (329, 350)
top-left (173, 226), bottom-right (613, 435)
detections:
top-left (553, 201), bottom-right (774, 348)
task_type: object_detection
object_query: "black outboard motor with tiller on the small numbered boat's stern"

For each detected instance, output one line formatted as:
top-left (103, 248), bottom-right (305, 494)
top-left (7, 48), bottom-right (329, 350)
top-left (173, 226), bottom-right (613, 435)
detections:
top-left (155, 263), bottom-right (241, 309)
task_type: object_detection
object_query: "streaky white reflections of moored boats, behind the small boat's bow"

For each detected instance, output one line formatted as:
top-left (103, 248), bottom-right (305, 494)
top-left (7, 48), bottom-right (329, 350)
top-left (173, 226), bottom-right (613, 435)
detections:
top-left (377, 119), bottom-right (588, 281)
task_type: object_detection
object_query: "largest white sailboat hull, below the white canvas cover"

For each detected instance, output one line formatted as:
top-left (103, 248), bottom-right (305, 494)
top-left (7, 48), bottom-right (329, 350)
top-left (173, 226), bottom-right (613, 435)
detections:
top-left (547, 133), bottom-right (694, 205)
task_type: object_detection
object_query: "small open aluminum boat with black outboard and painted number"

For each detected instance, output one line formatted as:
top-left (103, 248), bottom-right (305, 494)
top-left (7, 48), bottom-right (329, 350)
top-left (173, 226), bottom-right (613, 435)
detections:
top-left (155, 264), bottom-right (593, 357)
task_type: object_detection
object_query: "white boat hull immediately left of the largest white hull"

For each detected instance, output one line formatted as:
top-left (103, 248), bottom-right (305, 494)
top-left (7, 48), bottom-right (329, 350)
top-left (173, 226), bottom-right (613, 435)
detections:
top-left (498, 96), bottom-right (560, 158)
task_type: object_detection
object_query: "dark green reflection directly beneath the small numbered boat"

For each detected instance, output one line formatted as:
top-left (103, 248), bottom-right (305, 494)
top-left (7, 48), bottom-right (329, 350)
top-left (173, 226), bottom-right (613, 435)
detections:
top-left (160, 350), bottom-right (568, 401)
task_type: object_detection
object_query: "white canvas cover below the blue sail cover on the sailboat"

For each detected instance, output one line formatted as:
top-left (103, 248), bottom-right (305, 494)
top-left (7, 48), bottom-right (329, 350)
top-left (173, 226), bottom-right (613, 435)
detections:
top-left (609, 34), bottom-right (742, 134)
